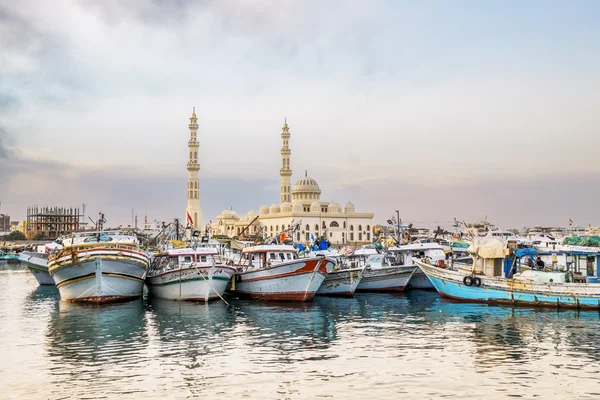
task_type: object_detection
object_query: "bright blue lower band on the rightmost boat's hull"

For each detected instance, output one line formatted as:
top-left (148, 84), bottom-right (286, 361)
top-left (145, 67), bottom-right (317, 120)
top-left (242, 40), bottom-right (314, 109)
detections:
top-left (429, 276), bottom-right (600, 309)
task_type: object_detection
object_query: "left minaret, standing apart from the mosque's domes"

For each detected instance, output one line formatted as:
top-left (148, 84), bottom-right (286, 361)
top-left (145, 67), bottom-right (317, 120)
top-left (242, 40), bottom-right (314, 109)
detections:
top-left (185, 107), bottom-right (202, 230)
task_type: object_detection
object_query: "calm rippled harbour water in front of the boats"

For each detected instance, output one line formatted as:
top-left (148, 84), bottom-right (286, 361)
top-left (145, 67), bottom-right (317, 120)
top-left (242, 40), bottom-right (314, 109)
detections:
top-left (0, 270), bottom-right (600, 399)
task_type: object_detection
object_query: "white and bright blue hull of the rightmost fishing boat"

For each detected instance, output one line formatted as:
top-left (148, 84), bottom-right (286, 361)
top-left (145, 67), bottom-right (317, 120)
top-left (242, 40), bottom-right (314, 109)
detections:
top-left (417, 262), bottom-right (600, 309)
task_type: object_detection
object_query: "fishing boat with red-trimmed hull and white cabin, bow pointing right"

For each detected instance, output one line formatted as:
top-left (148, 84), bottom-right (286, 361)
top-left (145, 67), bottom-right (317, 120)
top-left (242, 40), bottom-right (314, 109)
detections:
top-left (230, 244), bottom-right (336, 301)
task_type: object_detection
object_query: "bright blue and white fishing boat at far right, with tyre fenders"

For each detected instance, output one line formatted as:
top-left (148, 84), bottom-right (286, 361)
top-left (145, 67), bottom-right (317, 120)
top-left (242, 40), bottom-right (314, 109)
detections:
top-left (414, 239), bottom-right (600, 309)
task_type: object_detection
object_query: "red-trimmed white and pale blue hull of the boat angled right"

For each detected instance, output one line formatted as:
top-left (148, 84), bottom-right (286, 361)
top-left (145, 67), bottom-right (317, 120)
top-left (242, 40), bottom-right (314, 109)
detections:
top-left (231, 257), bottom-right (335, 301)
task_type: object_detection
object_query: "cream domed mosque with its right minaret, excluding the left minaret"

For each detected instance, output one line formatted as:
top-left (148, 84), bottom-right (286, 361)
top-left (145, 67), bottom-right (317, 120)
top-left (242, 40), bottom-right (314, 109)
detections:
top-left (209, 120), bottom-right (373, 245)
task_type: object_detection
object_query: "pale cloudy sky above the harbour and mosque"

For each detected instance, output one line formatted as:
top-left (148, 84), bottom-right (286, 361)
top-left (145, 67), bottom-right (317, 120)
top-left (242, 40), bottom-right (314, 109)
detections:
top-left (0, 0), bottom-right (600, 228)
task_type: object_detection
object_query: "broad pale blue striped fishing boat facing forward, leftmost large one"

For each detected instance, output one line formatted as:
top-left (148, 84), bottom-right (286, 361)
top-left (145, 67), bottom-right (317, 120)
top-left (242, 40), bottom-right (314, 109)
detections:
top-left (48, 224), bottom-right (150, 303)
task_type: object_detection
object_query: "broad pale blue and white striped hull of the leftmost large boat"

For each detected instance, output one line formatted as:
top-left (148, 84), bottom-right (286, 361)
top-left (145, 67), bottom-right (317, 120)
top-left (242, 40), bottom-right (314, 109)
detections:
top-left (49, 249), bottom-right (149, 303)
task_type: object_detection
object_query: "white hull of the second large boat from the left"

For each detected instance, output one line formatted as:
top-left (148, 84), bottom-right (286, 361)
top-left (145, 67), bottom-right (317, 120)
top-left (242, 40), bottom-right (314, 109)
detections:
top-left (146, 266), bottom-right (235, 301)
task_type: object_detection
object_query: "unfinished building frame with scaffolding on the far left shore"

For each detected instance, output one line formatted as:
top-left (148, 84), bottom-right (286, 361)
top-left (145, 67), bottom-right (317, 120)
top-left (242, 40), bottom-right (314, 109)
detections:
top-left (26, 206), bottom-right (83, 240)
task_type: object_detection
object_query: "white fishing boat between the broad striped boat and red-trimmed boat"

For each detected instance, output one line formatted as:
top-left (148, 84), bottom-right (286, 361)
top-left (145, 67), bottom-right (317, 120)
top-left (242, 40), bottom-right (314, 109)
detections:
top-left (146, 246), bottom-right (236, 301)
